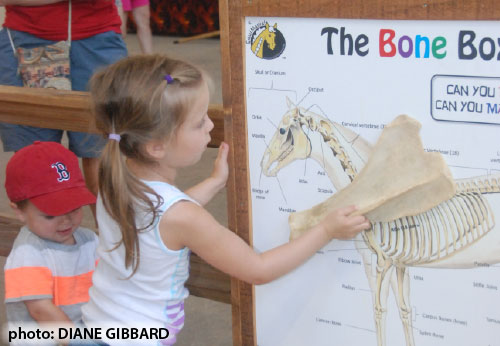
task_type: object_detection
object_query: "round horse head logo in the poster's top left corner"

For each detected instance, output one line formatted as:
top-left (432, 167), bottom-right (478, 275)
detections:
top-left (247, 22), bottom-right (286, 60)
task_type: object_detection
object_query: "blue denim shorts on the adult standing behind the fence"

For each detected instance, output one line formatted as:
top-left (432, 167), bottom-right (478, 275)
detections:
top-left (0, 28), bottom-right (127, 158)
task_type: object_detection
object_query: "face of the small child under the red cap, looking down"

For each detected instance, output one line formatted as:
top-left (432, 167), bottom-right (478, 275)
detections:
top-left (12, 201), bottom-right (83, 245)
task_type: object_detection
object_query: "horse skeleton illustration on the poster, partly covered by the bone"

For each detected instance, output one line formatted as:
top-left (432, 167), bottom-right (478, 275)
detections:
top-left (261, 99), bottom-right (500, 346)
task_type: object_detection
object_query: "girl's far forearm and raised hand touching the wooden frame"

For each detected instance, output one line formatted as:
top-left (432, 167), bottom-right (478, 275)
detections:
top-left (184, 142), bottom-right (229, 205)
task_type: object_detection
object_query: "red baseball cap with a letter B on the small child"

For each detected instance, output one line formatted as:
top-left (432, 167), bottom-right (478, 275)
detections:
top-left (5, 141), bottom-right (96, 216)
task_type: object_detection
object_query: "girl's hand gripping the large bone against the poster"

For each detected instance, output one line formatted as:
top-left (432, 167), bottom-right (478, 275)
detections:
top-left (321, 205), bottom-right (370, 239)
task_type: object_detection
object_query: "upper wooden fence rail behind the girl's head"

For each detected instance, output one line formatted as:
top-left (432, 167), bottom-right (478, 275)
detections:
top-left (0, 86), bottom-right (224, 148)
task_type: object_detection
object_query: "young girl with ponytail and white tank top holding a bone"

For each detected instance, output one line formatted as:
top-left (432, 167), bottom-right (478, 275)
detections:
top-left (83, 55), bottom-right (369, 345)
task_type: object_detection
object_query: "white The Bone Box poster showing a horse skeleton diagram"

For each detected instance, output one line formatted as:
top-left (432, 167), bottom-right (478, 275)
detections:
top-left (245, 17), bottom-right (500, 346)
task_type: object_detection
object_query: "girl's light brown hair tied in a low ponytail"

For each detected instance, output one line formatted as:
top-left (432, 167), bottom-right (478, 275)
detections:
top-left (90, 55), bottom-right (207, 275)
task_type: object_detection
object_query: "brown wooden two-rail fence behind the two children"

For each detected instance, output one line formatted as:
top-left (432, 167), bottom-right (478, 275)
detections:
top-left (0, 86), bottom-right (231, 303)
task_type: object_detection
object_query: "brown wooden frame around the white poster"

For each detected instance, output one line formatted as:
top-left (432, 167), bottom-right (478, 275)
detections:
top-left (219, 0), bottom-right (500, 345)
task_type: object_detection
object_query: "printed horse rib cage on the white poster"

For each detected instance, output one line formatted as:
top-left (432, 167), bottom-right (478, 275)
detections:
top-left (363, 178), bottom-right (500, 265)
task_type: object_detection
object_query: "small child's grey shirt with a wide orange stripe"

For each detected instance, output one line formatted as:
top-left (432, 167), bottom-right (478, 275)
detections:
top-left (4, 226), bottom-right (97, 322)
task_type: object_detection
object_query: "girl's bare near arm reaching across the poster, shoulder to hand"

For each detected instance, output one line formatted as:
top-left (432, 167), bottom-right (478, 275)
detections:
top-left (160, 202), bottom-right (369, 284)
